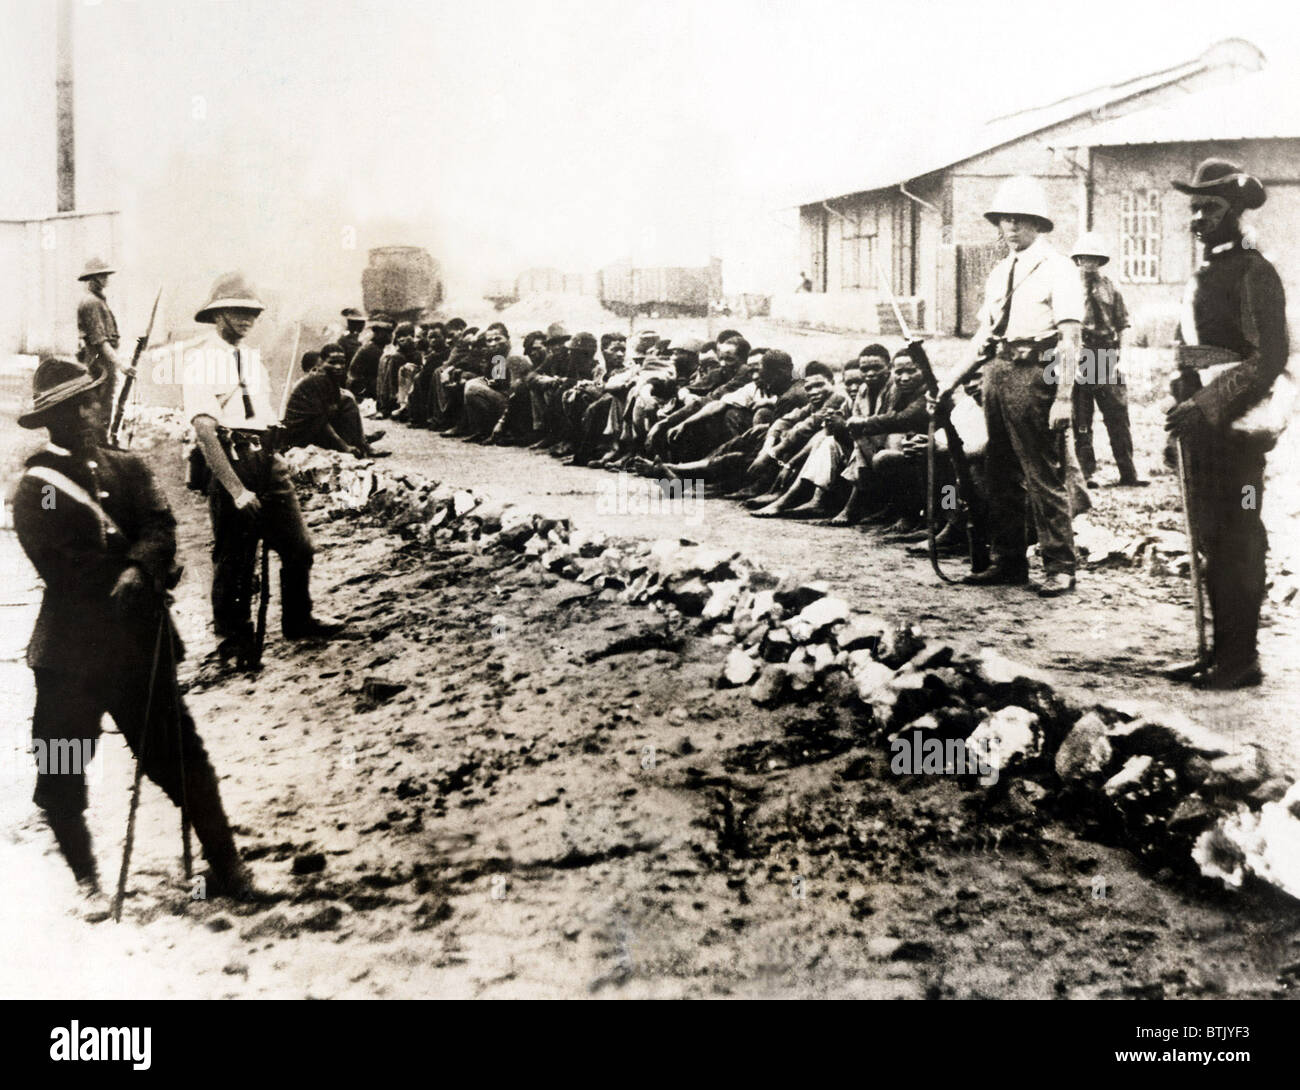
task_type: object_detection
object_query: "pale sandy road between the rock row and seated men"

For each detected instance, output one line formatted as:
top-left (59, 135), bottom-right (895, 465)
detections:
top-left (381, 421), bottom-right (1300, 774)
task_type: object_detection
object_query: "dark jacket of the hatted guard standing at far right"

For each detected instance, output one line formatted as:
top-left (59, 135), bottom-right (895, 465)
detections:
top-left (1179, 242), bottom-right (1290, 429)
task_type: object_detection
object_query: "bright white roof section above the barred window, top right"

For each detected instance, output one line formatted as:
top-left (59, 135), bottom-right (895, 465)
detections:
top-left (1084, 72), bottom-right (1300, 147)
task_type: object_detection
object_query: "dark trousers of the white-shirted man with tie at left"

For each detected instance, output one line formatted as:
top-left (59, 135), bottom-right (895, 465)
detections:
top-left (208, 441), bottom-right (316, 640)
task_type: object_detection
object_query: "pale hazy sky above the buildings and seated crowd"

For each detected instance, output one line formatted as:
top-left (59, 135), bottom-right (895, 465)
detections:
top-left (0, 0), bottom-right (1300, 316)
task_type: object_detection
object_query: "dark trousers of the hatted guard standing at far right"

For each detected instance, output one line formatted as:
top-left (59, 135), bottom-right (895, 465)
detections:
top-left (1184, 432), bottom-right (1269, 670)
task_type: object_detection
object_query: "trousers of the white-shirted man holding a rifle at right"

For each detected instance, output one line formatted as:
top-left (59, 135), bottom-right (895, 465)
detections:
top-left (984, 359), bottom-right (1075, 575)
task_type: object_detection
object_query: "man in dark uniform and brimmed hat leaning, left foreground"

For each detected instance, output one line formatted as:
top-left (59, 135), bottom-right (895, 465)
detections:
top-left (13, 358), bottom-right (263, 900)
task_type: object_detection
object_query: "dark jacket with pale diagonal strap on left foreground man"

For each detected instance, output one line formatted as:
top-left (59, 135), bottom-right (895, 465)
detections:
top-left (13, 445), bottom-right (176, 675)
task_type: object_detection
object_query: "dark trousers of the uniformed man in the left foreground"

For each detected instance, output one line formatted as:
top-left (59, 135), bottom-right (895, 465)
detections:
top-left (31, 652), bottom-right (238, 878)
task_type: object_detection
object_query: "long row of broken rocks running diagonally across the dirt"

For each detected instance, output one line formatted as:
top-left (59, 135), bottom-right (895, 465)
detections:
top-left (122, 420), bottom-right (1300, 899)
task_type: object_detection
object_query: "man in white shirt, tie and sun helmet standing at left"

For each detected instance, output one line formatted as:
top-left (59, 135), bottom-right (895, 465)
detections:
top-left (185, 273), bottom-right (343, 665)
